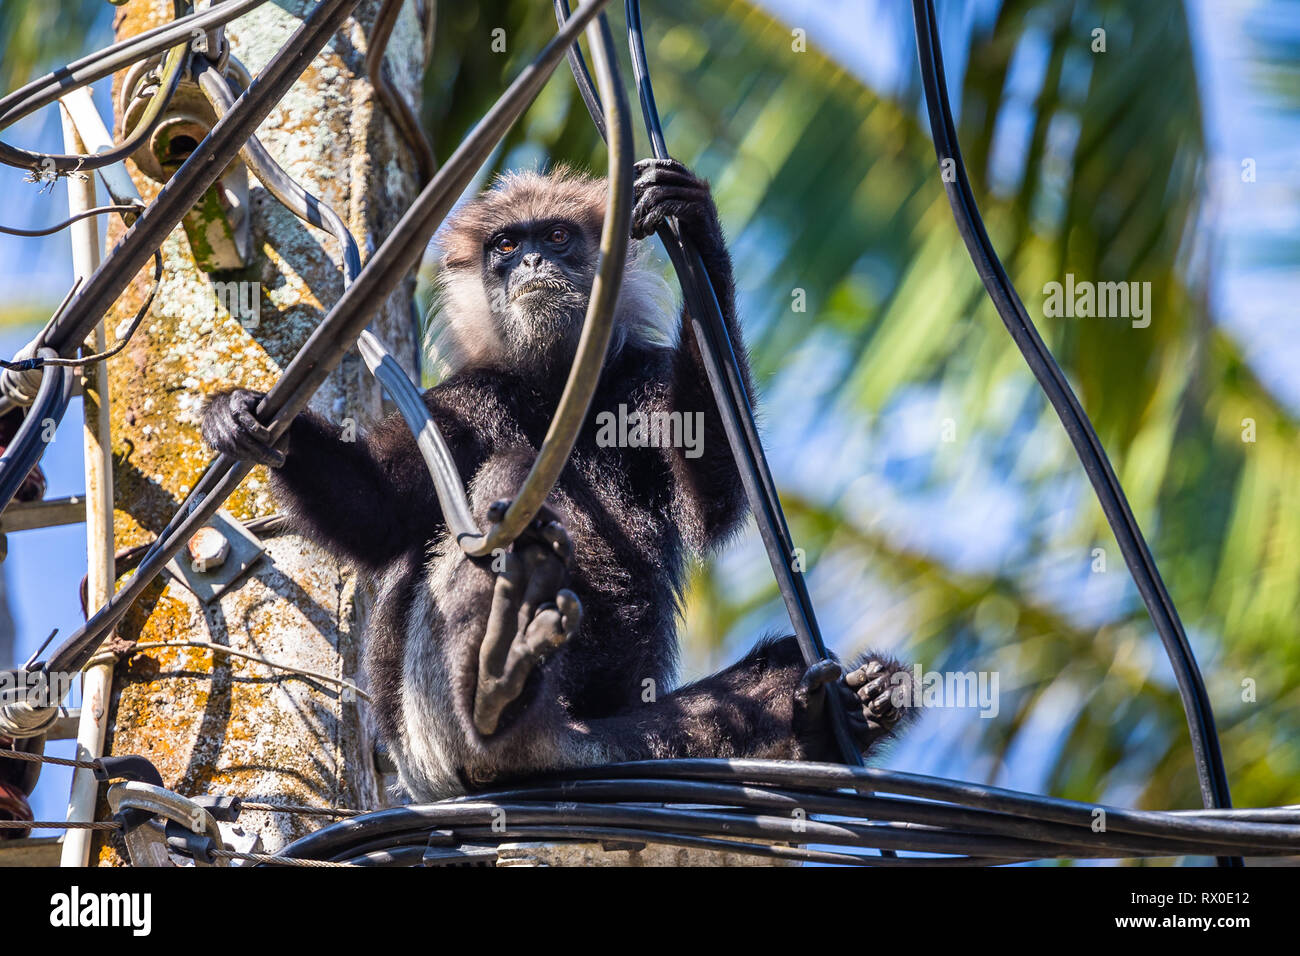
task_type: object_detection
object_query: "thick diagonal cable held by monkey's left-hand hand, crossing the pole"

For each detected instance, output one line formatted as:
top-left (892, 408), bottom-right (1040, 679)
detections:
top-left (43, 0), bottom-right (608, 672)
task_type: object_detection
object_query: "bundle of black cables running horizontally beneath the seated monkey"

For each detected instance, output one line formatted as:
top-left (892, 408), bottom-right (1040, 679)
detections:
top-left (261, 760), bottom-right (1300, 866)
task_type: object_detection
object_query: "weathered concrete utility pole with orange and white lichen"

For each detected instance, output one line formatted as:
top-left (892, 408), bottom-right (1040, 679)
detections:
top-left (98, 0), bottom-right (425, 862)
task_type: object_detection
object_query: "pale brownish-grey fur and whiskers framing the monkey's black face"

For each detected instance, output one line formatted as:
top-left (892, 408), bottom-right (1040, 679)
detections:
top-left (425, 165), bottom-right (679, 375)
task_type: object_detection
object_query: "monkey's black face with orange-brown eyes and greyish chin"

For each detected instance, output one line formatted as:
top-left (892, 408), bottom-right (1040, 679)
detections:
top-left (484, 219), bottom-right (595, 350)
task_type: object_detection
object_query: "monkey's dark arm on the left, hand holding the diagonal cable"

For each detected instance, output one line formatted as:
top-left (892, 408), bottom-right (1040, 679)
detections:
top-left (203, 389), bottom-right (442, 568)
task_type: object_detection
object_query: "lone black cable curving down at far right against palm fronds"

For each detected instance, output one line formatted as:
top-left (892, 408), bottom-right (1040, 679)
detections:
top-left (913, 0), bottom-right (1240, 865)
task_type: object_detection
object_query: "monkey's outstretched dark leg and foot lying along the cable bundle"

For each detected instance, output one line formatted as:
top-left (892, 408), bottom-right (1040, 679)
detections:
top-left (590, 637), bottom-right (914, 762)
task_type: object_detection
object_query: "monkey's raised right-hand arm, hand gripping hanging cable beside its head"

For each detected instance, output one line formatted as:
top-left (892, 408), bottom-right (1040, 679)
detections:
top-left (632, 160), bottom-right (754, 550)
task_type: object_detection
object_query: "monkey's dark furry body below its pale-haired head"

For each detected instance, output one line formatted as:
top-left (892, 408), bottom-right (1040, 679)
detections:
top-left (204, 164), bottom-right (915, 800)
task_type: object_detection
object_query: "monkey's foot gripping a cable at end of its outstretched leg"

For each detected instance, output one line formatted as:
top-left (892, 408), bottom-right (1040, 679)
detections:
top-left (794, 656), bottom-right (913, 762)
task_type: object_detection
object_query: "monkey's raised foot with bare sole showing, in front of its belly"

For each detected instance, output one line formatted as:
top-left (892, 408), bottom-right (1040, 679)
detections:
top-left (475, 519), bottom-right (582, 737)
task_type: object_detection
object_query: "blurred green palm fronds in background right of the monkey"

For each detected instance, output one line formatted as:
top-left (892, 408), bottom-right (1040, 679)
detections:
top-left (425, 0), bottom-right (1300, 822)
